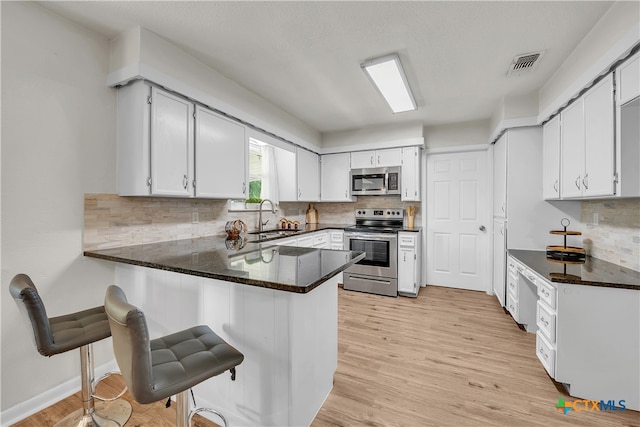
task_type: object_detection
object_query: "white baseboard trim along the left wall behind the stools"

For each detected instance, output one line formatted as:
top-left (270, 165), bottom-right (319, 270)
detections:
top-left (0, 360), bottom-right (119, 426)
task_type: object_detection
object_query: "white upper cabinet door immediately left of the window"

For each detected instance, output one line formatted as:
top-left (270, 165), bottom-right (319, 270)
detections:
top-left (195, 106), bottom-right (248, 199)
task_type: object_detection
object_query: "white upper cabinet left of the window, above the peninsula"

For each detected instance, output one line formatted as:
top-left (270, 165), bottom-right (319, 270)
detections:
top-left (117, 80), bottom-right (247, 198)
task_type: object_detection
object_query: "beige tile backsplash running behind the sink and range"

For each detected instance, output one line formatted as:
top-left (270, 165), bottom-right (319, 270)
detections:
top-left (83, 194), bottom-right (420, 250)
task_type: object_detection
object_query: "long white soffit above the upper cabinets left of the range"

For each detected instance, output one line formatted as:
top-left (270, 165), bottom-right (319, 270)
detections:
top-left (109, 27), bottom-right (320, 152)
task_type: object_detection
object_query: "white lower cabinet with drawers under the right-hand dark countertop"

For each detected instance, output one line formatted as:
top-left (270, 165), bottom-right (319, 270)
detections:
top-left (507, 257), bottom-right (640, 410)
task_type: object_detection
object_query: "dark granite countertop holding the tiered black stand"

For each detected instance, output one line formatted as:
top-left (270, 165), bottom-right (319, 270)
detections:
top-left (508, 249), bottom-right (640, 291)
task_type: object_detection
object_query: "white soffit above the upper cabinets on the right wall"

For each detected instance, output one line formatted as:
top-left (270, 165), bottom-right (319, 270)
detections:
top-left (538, 1), bottom-right (640, 121)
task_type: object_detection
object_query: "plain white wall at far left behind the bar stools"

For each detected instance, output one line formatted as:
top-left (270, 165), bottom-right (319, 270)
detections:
top-left (0, 2), bottom-right (116, 418)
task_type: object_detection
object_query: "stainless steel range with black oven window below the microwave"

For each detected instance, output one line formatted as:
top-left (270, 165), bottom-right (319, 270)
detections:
top-left (344, 208), bottom-right (404, 297)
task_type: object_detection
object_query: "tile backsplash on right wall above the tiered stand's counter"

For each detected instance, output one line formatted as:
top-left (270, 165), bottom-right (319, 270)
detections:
top-left (581, 198), bottom-right (640, 271)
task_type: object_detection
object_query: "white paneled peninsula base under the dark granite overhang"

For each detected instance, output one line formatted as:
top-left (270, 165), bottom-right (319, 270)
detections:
top-left (116, 264), bottom-right (342, 426)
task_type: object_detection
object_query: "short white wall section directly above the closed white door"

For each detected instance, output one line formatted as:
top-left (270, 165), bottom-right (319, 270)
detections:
top-left (424, 120), bottom-right (490, 150)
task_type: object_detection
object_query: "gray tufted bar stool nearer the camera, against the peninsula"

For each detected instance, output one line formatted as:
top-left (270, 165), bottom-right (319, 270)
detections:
top-left (104, 285), bottom-right (244, 427)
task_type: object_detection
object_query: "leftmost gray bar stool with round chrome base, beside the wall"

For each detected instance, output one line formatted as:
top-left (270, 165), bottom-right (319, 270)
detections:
top-left (9, 274), bottom-right (131, 427)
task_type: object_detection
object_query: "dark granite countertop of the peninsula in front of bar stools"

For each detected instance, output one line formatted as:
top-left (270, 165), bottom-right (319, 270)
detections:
top-left (84, 236), bottom-right (364, 293)
